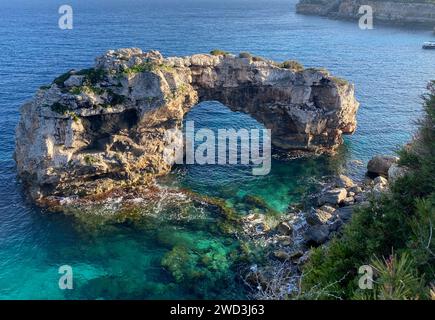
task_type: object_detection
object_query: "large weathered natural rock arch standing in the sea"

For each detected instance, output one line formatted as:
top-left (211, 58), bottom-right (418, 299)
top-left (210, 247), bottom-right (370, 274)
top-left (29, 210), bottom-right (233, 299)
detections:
top-left (15, 49), bottom-right (358, 204)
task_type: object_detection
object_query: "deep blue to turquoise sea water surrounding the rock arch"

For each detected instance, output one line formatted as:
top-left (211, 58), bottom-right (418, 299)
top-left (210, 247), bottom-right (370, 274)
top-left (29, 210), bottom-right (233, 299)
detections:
top-left (0, 0), bottom-right (435, 299)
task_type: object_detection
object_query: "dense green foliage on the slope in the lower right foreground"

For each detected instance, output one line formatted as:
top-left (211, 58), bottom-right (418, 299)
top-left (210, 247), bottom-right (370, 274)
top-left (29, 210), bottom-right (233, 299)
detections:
top-left (302, 82), bottom-right (435, 299)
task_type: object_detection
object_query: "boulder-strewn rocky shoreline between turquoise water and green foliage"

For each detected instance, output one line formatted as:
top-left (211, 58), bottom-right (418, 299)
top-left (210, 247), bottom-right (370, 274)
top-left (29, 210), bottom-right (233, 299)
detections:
top-left (243, 156), bottom-right (407, 299)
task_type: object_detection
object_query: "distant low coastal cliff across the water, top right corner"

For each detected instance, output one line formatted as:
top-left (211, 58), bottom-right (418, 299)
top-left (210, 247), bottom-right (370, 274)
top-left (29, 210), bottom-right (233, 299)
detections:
top-left (296, 0), bottom-right (435, 27)
